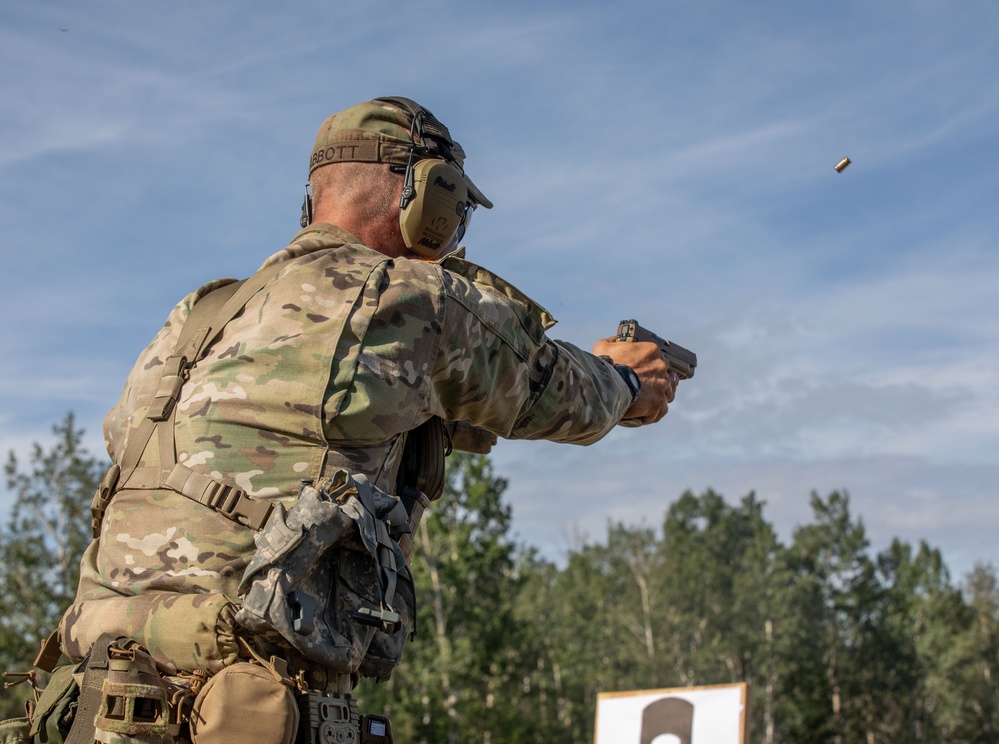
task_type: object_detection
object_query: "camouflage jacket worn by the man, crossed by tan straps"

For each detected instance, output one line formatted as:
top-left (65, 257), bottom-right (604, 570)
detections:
top-left (60, 224), bottom-right (631, 671)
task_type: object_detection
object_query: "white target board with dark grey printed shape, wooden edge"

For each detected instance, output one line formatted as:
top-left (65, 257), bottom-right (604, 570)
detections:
top-left (594, 682), bottom-right (749, 744)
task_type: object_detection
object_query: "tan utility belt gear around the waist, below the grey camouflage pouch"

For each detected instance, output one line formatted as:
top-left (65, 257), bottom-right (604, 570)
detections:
top-left (0, 634), bottom-right (392, 744)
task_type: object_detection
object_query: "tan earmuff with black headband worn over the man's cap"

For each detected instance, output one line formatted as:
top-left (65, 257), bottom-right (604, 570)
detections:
top-left (377, 98), bottom-right (480, 258)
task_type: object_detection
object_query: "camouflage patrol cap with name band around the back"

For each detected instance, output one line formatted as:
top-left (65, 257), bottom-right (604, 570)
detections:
top-left (309, 99), bottom-right (493, 209)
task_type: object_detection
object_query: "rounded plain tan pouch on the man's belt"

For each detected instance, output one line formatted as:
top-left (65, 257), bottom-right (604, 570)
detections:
top-left (191, 662), bottom-right (299, 744)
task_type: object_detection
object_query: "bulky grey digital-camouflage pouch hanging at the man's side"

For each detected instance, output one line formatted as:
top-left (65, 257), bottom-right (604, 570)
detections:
top-left (236, 470), bottom-right (415, 678)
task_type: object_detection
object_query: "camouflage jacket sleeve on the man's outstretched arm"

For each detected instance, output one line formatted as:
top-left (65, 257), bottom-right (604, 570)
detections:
top-left (433, 259), bottom-right (631, 444)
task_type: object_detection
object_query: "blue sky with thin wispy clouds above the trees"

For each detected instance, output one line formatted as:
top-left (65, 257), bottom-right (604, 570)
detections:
top-left (0, 0), bottom-right (999, 578)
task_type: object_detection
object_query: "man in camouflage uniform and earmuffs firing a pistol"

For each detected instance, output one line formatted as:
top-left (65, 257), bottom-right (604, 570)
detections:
top-left (52, 98), bottom-right (677, 742)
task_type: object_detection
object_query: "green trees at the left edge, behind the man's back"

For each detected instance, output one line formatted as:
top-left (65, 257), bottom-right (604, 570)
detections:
top-left (0, 413), bottom-right (102, 715)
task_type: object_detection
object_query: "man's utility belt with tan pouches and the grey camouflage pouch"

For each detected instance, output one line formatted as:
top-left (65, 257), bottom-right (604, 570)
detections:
top-left (7, 462), bottom-right (429, 744)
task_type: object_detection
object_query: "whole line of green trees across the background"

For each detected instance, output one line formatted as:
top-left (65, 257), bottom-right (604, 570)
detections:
top-left (0, 415), bottom-right (999, 744)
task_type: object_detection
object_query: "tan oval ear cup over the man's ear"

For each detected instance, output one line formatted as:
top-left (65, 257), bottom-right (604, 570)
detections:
top-left (399, 158), bottom-right (468, 258)
